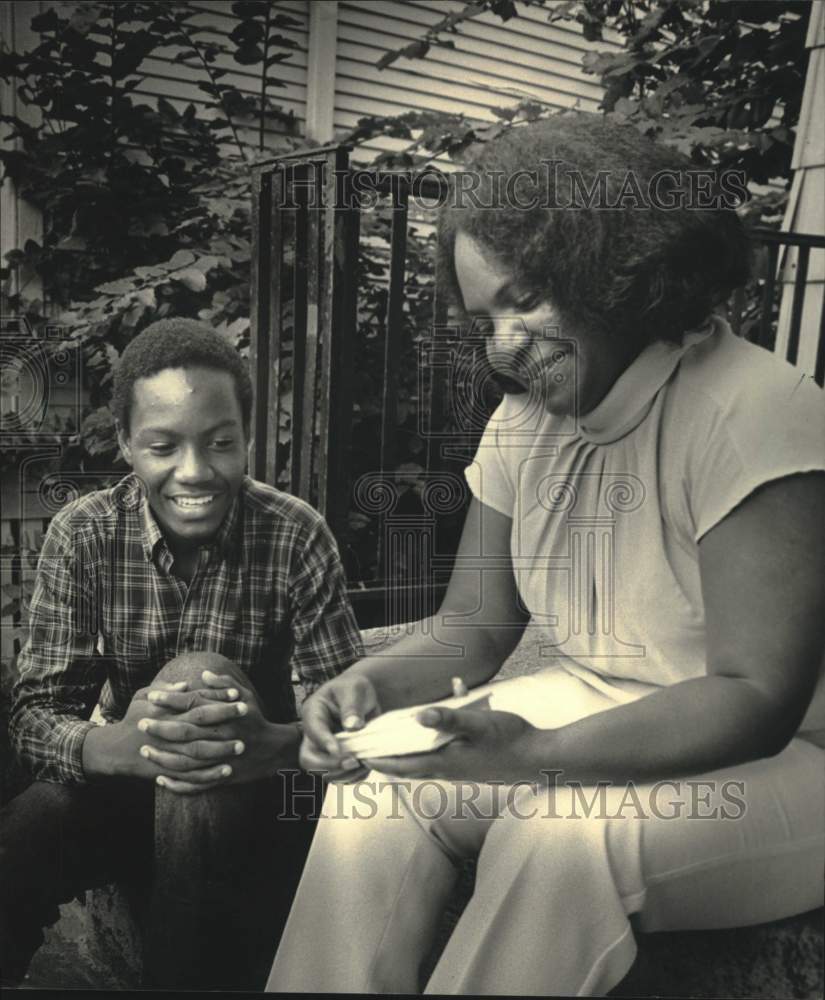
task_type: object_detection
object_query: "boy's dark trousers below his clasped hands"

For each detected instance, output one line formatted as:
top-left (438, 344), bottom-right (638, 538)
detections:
top-left (0, 773), bottom-right (321, 989)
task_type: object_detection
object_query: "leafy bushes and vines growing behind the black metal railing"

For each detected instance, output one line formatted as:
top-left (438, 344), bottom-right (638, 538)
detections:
top-left (0, 0), bottom-right (809, 592)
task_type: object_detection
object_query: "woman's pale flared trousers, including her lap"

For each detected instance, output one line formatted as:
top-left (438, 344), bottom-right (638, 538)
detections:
top-left (270, 671), bottom-right (825, 994)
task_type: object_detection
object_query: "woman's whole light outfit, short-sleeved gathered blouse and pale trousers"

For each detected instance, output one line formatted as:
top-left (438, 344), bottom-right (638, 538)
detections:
top-left (267, 320), bottom-right (825, 996)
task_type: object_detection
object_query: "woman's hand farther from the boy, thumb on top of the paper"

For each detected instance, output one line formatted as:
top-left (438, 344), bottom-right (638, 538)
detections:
top-left (364, 708), bottom-right (541, 784)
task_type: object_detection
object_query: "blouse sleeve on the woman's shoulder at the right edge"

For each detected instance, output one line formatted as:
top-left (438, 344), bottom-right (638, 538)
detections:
top-left (688, 366), bottom-right (825, 542)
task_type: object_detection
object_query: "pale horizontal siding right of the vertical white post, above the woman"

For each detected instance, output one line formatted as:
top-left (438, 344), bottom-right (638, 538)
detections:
top-left (334, 0), bottom-right (618, 160)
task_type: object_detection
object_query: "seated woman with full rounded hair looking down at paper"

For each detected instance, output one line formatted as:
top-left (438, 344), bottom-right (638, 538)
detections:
top-left (268, 114), bottom-right (825, 996)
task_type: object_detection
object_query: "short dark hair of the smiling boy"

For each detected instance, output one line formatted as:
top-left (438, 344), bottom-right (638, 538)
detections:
top-left (111, 318), bottom-right (252, 433)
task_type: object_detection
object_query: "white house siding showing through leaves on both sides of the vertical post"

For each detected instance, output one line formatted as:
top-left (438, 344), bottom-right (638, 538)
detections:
top-left (0, 0), bottom-right (618, 253)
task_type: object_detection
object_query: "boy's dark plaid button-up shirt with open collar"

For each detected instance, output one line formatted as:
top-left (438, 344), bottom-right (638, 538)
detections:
top-left (10, 475), bottom-right (363, 783)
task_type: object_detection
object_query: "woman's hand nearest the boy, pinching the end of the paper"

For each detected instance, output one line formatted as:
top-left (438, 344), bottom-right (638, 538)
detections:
top-left (300, 673), bottom-right (381, 781)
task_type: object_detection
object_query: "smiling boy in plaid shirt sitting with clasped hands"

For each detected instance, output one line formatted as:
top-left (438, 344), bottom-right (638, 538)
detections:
top-left (0, 320), bottom-right (362, 985)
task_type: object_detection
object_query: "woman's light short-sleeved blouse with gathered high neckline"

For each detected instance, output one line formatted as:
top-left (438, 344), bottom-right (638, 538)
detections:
top-left (465, 318), bottom-right (825, 740)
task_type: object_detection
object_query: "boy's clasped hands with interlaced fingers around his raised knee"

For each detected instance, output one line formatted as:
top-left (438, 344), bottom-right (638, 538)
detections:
top-left (113, 670), bottom-right (298, 794)
